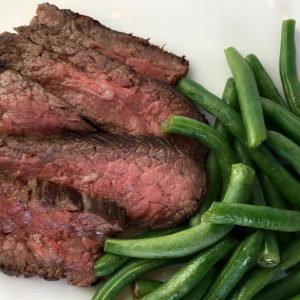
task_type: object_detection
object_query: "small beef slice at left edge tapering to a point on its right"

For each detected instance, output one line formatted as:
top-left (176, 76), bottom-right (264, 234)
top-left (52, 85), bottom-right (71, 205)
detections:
top-left (0, 70), bottom-right (94, 136)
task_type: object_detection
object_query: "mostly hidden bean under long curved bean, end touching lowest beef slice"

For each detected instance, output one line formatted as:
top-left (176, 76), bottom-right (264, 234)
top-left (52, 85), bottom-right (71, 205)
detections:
top-left (94, 226), bottom-right (184, 277)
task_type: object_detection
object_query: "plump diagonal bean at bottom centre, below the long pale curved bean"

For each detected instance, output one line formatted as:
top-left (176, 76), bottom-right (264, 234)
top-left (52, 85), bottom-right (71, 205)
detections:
top-left (142, 238), bottom-right (236, 300)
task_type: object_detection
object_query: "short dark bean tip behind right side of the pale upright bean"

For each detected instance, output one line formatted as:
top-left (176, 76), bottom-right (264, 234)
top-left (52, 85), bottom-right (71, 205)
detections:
top-left (246, 54), bottom-right (286, 107)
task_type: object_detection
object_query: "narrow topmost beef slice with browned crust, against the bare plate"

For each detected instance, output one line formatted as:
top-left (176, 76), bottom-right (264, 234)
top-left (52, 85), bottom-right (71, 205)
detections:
top-left (31, 3), bottom-right (189, 84)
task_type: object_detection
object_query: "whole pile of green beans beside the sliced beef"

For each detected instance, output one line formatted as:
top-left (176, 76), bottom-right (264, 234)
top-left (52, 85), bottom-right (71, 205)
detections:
top-left (93, 20), bottom-right (300, 300)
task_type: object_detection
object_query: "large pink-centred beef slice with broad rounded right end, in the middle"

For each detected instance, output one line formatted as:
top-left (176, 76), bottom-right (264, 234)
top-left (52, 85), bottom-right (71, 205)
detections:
top-left (0, 134), bottom-right (206, 228)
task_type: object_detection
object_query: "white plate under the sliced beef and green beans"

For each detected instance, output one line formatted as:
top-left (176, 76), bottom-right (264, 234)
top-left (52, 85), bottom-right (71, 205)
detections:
top-left (0, 0), bottom-right (300, 300)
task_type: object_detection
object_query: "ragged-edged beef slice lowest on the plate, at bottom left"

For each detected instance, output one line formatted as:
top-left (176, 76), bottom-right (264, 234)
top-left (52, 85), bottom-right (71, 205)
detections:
top-left (0, 175), bottom-right (124, 286)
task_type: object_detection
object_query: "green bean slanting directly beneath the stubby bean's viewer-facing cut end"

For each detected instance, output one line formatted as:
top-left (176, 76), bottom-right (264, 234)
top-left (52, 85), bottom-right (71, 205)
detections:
top-left (230, 239), bottom-right (300, 300)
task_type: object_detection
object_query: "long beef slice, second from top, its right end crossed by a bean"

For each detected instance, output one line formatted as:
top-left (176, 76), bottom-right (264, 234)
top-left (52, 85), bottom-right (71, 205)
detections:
top-left (0, 32), bottom-right (206, 158)
